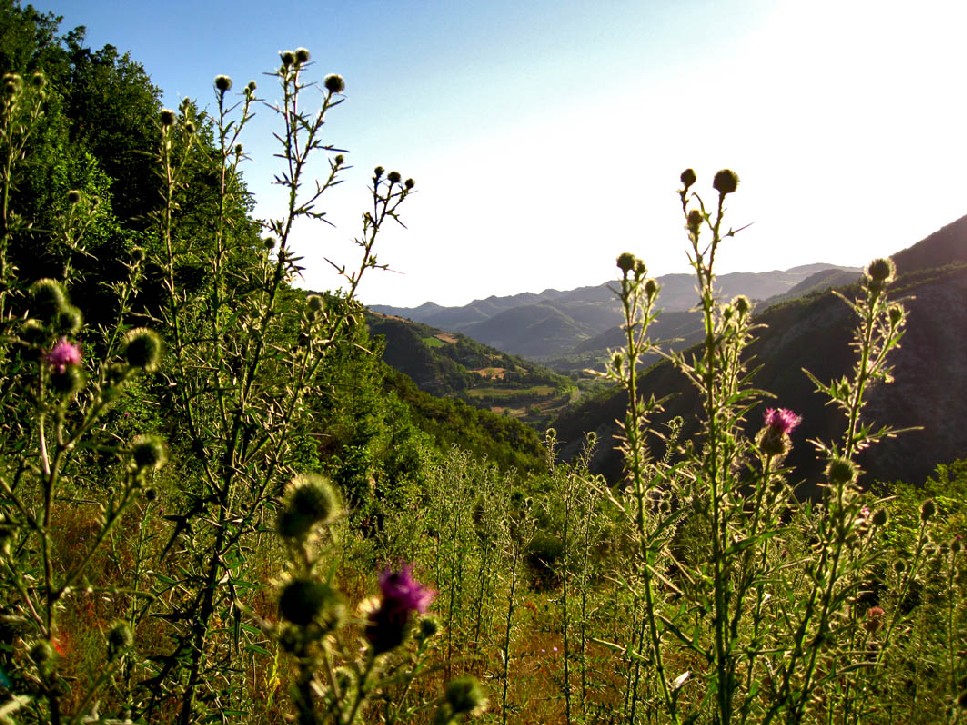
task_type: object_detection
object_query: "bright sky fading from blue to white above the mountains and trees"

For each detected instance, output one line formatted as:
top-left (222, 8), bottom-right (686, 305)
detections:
top-left (26, 0), bottom-right (967, 307)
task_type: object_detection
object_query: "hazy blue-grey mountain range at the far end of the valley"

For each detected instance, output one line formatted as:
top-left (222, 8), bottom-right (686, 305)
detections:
top-left (371, 264), bottom-right (859, 364)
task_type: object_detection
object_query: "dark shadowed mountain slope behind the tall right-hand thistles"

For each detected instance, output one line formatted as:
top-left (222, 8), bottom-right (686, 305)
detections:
top-left (554, 212), bottom-right (967, 496)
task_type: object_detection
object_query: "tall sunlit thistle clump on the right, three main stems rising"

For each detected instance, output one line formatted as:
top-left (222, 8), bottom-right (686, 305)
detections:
top-left (606, 169), bottom-right (917, 723)
